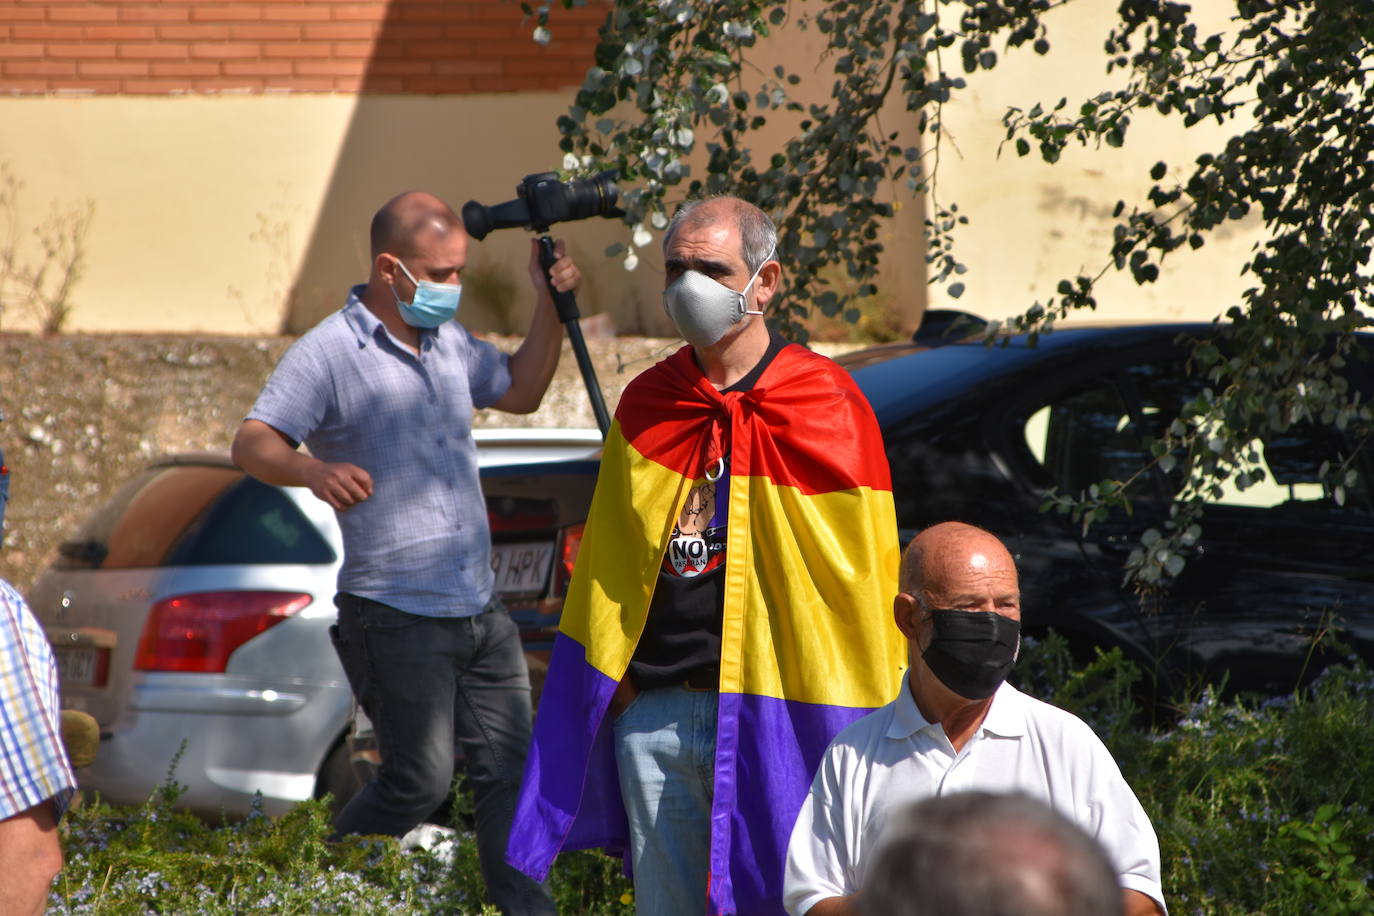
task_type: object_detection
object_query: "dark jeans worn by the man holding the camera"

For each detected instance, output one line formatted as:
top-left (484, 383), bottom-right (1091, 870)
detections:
top-left (331, 593), bottom-right (555, 915)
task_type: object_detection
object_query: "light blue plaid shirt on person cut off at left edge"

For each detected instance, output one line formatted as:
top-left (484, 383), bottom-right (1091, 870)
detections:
top-left (0, 580), bottom-right (77, 818)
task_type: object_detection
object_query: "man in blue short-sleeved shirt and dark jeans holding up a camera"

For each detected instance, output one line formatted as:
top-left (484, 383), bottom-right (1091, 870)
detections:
top-left (232, 191), bottom-right (580, 913)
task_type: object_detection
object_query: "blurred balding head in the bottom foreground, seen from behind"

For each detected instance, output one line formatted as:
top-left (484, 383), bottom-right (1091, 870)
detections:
top-left (859, 792), bottom-right (1123, 916)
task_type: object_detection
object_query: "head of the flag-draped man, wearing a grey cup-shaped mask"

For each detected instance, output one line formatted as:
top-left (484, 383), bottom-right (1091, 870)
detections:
top-left (664, 198), bottom-right (782, 349)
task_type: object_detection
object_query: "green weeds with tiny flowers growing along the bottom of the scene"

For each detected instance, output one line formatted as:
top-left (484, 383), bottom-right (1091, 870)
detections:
top-left (48, 636), bottom-right (1374, 916)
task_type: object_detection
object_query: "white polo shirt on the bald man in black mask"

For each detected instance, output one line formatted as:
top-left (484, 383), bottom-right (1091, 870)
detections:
top-left (783, 676), bottom-right (1164, 916)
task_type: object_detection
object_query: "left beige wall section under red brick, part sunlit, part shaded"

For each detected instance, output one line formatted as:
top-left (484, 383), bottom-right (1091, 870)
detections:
top-left (0, 92), bottom-right (653, 334)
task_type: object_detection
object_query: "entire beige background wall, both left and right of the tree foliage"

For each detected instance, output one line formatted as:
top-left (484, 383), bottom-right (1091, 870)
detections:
top-left (0, 4), bottom-right (1259, 335)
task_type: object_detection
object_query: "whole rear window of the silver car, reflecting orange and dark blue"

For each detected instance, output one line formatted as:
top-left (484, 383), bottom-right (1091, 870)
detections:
top-left (55, 466), bottom-right (335, 570)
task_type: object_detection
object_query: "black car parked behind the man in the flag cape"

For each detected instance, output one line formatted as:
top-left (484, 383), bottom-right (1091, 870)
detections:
top-left (840, 324), bottom-right (1374, 696)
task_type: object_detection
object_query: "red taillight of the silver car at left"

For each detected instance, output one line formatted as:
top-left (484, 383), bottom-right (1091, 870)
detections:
top-left (133, 592), bottom-right (311, 673)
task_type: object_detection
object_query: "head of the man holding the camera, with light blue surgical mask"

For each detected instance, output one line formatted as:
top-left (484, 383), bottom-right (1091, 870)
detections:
top-left (368, 191), bottom-right (467, 327)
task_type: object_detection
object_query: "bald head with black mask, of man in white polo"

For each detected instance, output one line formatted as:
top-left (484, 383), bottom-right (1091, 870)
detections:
top-left (893, 522), bottom-right (1021, 700)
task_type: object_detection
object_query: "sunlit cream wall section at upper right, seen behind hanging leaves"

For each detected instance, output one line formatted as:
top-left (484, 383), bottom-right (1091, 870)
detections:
top-left (930, 3), bottom-right (1263, 321)
